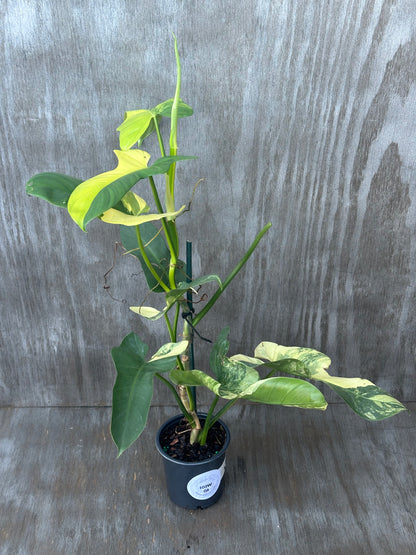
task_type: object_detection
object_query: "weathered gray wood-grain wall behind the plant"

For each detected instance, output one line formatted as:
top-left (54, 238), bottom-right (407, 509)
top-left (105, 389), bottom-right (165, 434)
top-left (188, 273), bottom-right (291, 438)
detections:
top-left (0, 0), bottom-right (416, 406)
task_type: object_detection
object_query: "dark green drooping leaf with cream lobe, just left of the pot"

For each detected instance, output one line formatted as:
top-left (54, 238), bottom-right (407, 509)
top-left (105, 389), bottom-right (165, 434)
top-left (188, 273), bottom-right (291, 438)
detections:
top-left (111, 333), bottom-right (188, 456)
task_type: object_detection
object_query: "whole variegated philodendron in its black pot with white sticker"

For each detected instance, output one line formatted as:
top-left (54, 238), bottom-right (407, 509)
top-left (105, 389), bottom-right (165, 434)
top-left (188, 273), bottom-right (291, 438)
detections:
top-left (26, 39), bottom-right (406, 508)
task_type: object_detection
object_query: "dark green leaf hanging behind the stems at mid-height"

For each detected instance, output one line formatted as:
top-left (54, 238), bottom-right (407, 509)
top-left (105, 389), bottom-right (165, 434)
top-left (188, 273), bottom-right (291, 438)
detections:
top-left (120, 222), bottom-right (186, 293)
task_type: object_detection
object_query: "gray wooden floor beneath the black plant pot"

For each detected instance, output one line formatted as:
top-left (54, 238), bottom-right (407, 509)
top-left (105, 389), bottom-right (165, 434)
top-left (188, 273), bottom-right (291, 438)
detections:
top-left (0, 403), bottom-right (416, 555)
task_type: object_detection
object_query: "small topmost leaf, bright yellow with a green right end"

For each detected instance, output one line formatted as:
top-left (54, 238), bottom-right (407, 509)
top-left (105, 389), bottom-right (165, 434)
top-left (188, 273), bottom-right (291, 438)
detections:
top-left (117, 98), bottom-right (193, 150)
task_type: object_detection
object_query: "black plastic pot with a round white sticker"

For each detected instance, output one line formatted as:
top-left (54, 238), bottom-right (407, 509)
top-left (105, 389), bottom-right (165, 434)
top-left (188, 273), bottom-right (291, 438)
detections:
top-left (156, 414), bottom-right (230, 509)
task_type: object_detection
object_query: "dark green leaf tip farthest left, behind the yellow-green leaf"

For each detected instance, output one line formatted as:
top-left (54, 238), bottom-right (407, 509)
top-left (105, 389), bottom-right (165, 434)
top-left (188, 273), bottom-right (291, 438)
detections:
top-left (26, 172), bottom-right (82, 208)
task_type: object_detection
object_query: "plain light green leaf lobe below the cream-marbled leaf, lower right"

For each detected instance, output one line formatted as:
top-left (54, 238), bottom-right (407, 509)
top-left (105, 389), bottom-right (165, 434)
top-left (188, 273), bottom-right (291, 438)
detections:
top-left (242, 377), bottom-right (327, 410)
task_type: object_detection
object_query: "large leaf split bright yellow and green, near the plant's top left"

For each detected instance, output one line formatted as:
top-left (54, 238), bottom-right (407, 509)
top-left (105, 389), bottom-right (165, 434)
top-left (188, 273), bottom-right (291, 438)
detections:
top-left (68, 150), bottom-right (196, 231)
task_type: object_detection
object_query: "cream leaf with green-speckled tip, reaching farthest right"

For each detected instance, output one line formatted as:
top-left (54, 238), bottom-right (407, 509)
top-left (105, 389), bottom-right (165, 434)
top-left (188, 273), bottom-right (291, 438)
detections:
top-left (255, 341), bottom-right (407, 420)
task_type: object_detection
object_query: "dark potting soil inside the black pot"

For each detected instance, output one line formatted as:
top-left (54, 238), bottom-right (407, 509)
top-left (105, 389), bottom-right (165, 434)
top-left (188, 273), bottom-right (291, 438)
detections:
top-left (160, 418), bottom-right (226, 462)
